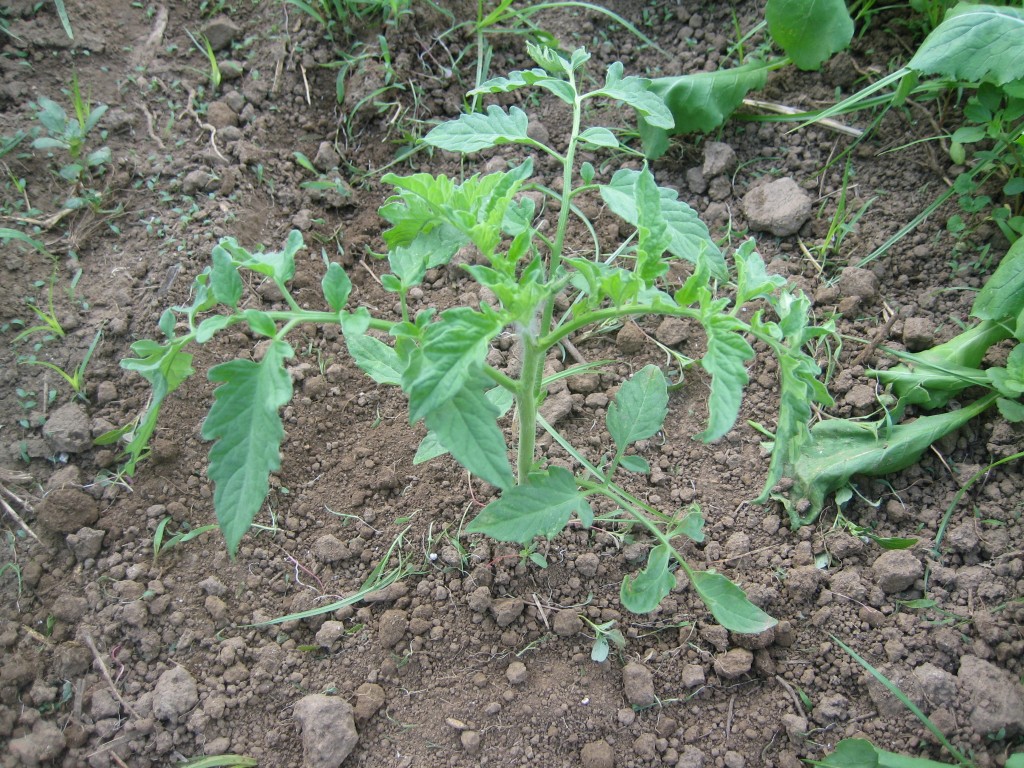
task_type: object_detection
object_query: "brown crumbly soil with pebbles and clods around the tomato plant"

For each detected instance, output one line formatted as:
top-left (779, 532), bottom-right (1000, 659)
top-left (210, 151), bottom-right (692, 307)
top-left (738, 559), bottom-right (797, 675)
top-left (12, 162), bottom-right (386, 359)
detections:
top-left (0, 0), bottom-right (1024, 768)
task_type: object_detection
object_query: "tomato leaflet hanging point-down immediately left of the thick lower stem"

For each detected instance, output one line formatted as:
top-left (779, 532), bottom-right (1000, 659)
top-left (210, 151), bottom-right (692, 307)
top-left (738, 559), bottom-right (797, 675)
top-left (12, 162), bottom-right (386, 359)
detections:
top-left (424, 383), bottom-right (515, 489)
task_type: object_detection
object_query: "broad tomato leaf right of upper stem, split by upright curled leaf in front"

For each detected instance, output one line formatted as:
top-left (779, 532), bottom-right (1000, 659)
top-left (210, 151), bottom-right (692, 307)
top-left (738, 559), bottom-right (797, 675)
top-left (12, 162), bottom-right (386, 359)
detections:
top-left (600, 168), bottom-right (728, 280)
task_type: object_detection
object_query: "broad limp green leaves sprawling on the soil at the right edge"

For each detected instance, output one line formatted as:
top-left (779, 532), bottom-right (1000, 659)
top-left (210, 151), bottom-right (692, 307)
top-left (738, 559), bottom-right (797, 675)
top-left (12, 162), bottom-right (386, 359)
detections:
top-left (776, 233), bottom-right (1024, 527)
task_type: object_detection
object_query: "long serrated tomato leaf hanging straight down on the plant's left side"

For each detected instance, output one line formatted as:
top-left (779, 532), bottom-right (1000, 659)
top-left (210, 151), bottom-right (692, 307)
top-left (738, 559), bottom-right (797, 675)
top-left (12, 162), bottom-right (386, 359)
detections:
top-left (202, 341), bottom-right (294, 557)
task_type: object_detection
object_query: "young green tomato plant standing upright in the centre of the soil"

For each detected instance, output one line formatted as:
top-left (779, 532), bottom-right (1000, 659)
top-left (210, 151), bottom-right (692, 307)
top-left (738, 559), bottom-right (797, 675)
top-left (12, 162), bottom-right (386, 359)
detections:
top-left (122, 44), bottom-right (831, 633)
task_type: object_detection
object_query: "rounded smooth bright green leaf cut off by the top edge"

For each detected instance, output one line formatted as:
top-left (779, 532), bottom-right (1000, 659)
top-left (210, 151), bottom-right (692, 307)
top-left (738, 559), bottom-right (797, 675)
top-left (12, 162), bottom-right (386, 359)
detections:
top-left (765, 0), bottom-right (853, 70)
